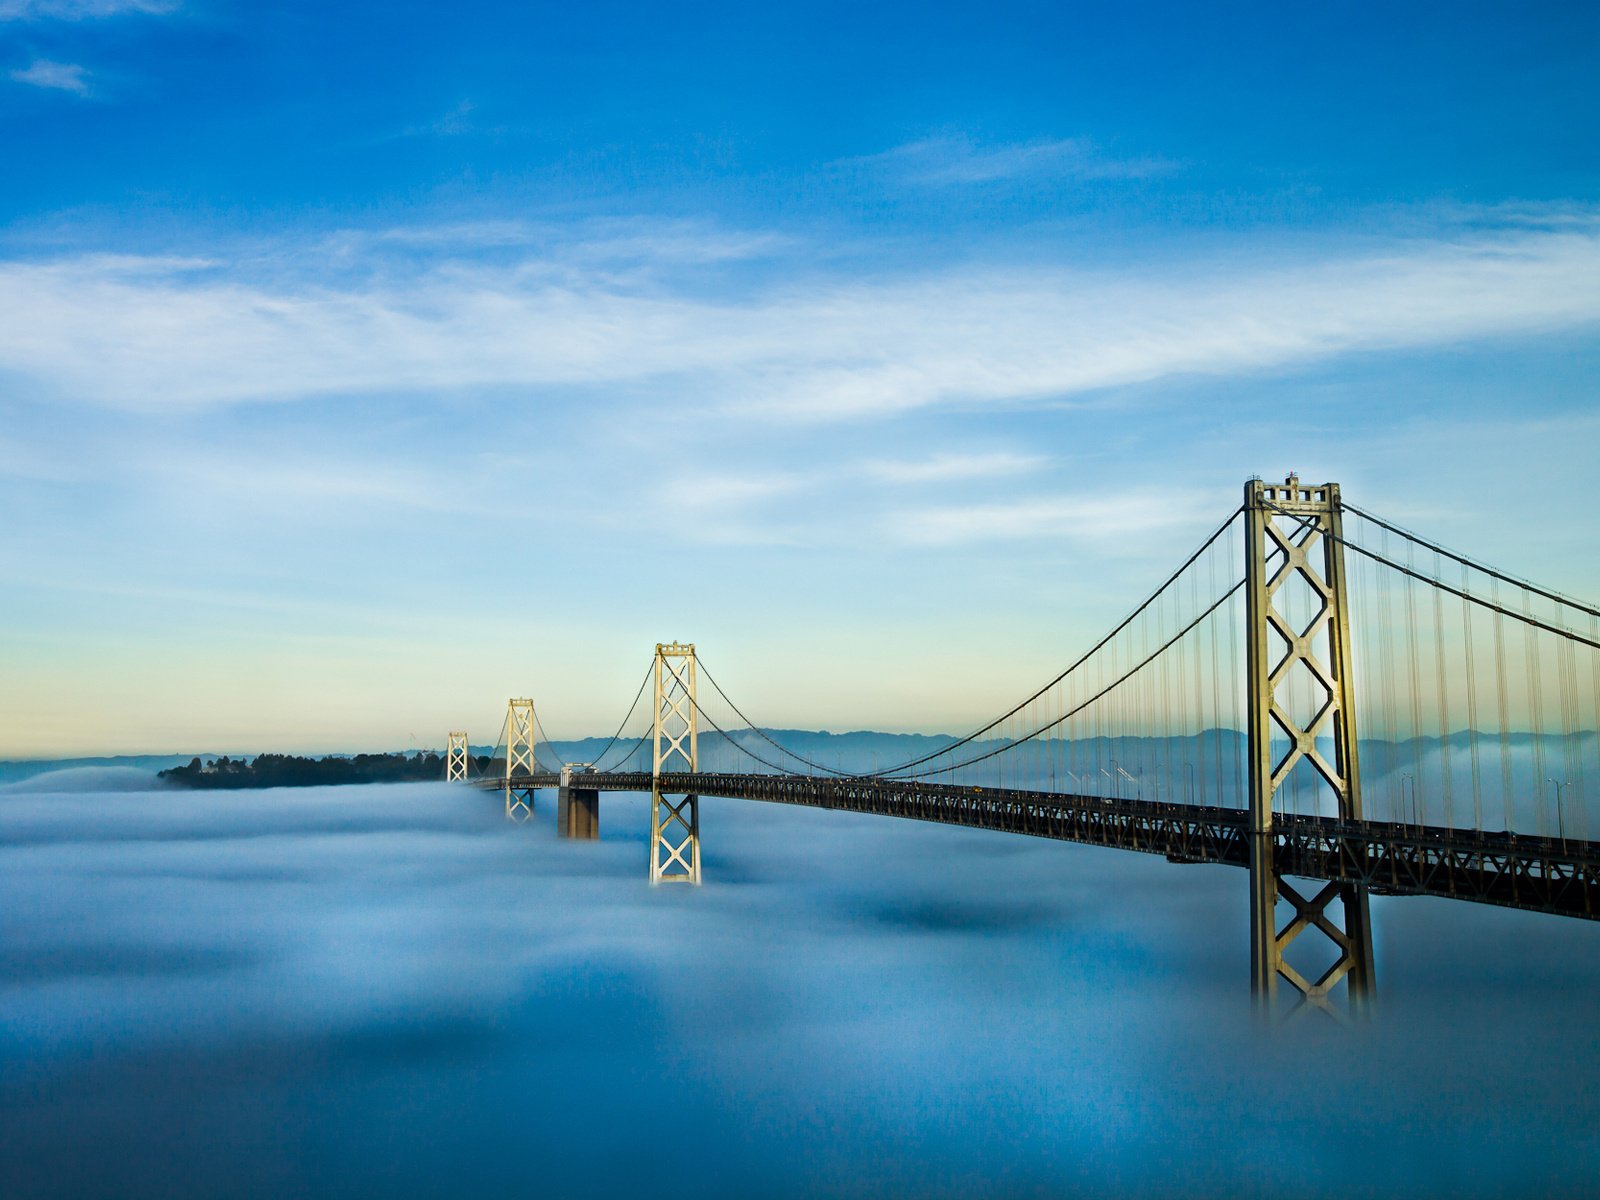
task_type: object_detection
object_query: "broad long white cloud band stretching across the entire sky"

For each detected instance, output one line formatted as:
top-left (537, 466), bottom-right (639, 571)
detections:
top-left (0, 219), bottom-right (1600, 421)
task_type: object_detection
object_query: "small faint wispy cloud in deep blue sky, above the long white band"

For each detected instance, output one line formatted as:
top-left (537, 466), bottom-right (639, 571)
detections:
top-left (848, 134), bottom-right (1179, 186)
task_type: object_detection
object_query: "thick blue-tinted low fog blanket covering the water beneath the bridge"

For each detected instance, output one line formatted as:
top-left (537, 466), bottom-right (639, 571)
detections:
top-left (0, 776), bottom-right (1600, 1200)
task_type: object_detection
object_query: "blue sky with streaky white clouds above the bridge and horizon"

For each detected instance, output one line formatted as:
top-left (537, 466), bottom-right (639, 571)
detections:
top-left (0, 0), bottom-right (1600, 755)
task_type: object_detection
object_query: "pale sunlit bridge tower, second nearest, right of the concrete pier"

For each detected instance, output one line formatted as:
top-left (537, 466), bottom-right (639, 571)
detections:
top-left (650, 642), bottom-right (701, 883)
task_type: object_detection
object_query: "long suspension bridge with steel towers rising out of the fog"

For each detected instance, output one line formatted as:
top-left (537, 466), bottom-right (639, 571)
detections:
top-left (446, 475), bottom-right (1600, 1011)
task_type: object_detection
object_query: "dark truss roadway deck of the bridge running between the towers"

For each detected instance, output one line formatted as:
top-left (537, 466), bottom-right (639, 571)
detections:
top-left (480, 771), bottom-right (1600, 920)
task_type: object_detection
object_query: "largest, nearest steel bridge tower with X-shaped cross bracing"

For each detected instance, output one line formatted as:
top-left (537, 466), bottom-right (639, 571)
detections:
top-left (1245, 475), bottom-right (1374, 1013)
